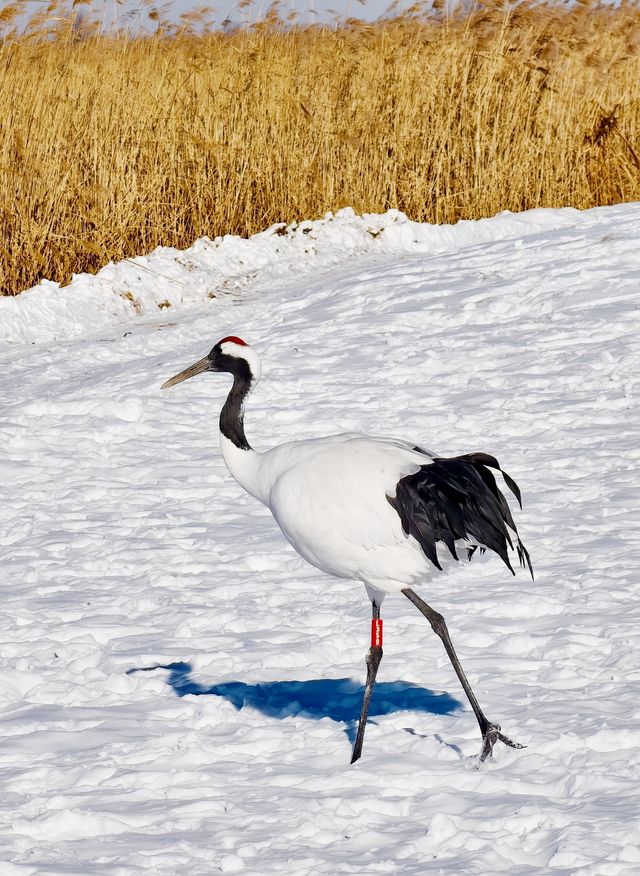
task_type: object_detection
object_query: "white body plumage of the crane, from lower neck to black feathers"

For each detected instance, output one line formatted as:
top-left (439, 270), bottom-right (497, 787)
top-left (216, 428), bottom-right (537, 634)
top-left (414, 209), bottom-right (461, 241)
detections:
top-left (220, 434), bottom-right (446, 602)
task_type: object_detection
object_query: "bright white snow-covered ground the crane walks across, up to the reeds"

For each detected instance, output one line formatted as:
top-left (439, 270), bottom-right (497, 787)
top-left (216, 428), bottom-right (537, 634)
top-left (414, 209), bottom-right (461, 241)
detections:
top-left (0, 204), bottom-right (640, 876)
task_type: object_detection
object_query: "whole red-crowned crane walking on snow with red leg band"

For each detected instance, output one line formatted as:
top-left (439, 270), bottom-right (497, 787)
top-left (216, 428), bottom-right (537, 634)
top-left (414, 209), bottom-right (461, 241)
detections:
top-left (162, 337), bottom-right (533, 763)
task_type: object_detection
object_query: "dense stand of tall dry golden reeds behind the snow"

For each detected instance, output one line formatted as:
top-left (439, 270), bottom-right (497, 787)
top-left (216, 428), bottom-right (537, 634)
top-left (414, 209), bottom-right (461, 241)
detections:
top-left (0, 2), bottom-right (640, 295)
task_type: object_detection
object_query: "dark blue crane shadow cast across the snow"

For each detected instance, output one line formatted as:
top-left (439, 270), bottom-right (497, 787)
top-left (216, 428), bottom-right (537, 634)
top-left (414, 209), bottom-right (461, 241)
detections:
top-left (127, 663), bottom-right (462, 743)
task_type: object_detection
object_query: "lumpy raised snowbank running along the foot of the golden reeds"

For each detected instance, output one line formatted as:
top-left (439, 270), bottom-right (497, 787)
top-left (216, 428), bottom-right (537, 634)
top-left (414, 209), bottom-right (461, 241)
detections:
top-left (0, 207), bottom-right (632, 345)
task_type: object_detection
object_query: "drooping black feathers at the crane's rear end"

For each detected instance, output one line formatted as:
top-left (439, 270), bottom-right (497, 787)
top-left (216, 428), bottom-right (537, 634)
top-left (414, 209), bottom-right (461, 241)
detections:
top-left (387, 453), bottom-right (533, 578)
